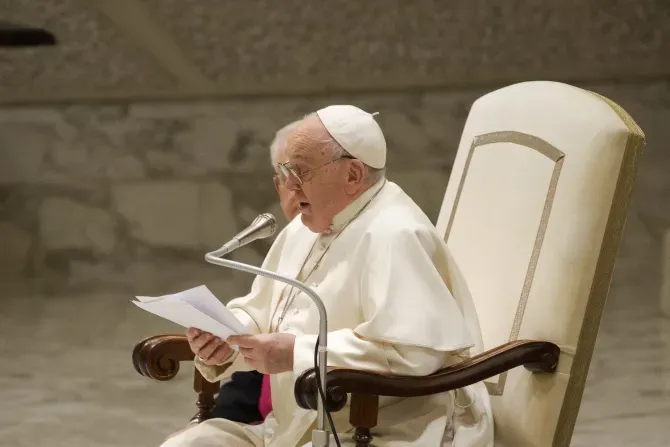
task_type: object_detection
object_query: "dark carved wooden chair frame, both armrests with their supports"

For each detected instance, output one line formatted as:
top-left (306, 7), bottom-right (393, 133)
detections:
top-left (133, 335), bottom-right (560, 447)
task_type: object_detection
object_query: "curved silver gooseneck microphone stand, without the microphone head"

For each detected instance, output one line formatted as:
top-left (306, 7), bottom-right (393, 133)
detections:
top-left (205, 245), bottom-right (330, 447)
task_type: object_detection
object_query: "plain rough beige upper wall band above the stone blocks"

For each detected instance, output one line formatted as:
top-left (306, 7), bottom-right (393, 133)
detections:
top-left (0, 0), bottom-right (670, 103)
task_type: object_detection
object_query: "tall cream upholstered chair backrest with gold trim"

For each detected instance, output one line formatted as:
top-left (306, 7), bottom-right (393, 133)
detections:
top-left (437, 81), bottom-right (645, 447)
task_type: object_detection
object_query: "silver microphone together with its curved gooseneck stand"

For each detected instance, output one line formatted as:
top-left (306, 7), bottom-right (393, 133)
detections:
top-left (205, 213), bottom-right (339, 447)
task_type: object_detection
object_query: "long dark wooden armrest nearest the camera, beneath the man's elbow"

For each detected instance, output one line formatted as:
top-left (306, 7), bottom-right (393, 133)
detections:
top-left (294, 340), bottom-right (560, 411)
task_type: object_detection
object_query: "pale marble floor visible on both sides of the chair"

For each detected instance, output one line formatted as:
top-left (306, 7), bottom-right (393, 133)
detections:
top-left (0, 296), bottom-right (670, 447)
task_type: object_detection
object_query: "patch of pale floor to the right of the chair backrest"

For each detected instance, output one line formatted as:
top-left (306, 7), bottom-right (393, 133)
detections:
top-left (572, 302), bottom-right (670, 447)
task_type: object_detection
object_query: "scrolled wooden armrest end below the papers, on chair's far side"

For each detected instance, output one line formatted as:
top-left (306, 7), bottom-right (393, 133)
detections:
top-left (133, 334), bottom-right (195, 381)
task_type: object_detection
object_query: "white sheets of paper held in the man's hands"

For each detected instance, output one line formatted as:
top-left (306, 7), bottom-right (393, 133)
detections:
top-left (132, 286), bottom-right (248, 340)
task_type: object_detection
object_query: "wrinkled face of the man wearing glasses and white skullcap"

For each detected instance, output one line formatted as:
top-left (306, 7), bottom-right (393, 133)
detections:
top-left (278, 117), bottom-right (366, 233)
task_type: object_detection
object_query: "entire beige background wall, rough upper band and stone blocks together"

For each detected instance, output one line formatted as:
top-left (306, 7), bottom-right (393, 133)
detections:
top-left (0, 0), bottom-right (670, 300)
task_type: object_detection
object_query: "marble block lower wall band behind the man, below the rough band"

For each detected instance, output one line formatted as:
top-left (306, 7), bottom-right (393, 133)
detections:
top-left (0, 82), bottom-right (670, 306)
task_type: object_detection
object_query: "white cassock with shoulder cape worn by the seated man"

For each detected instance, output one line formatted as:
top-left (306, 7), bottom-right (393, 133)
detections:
top-left (163, 180), bottom-right (493, 447)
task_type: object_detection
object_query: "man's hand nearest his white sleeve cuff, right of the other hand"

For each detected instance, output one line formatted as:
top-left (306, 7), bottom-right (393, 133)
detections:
top-left (228, 333), bottom-right (295, 374)
